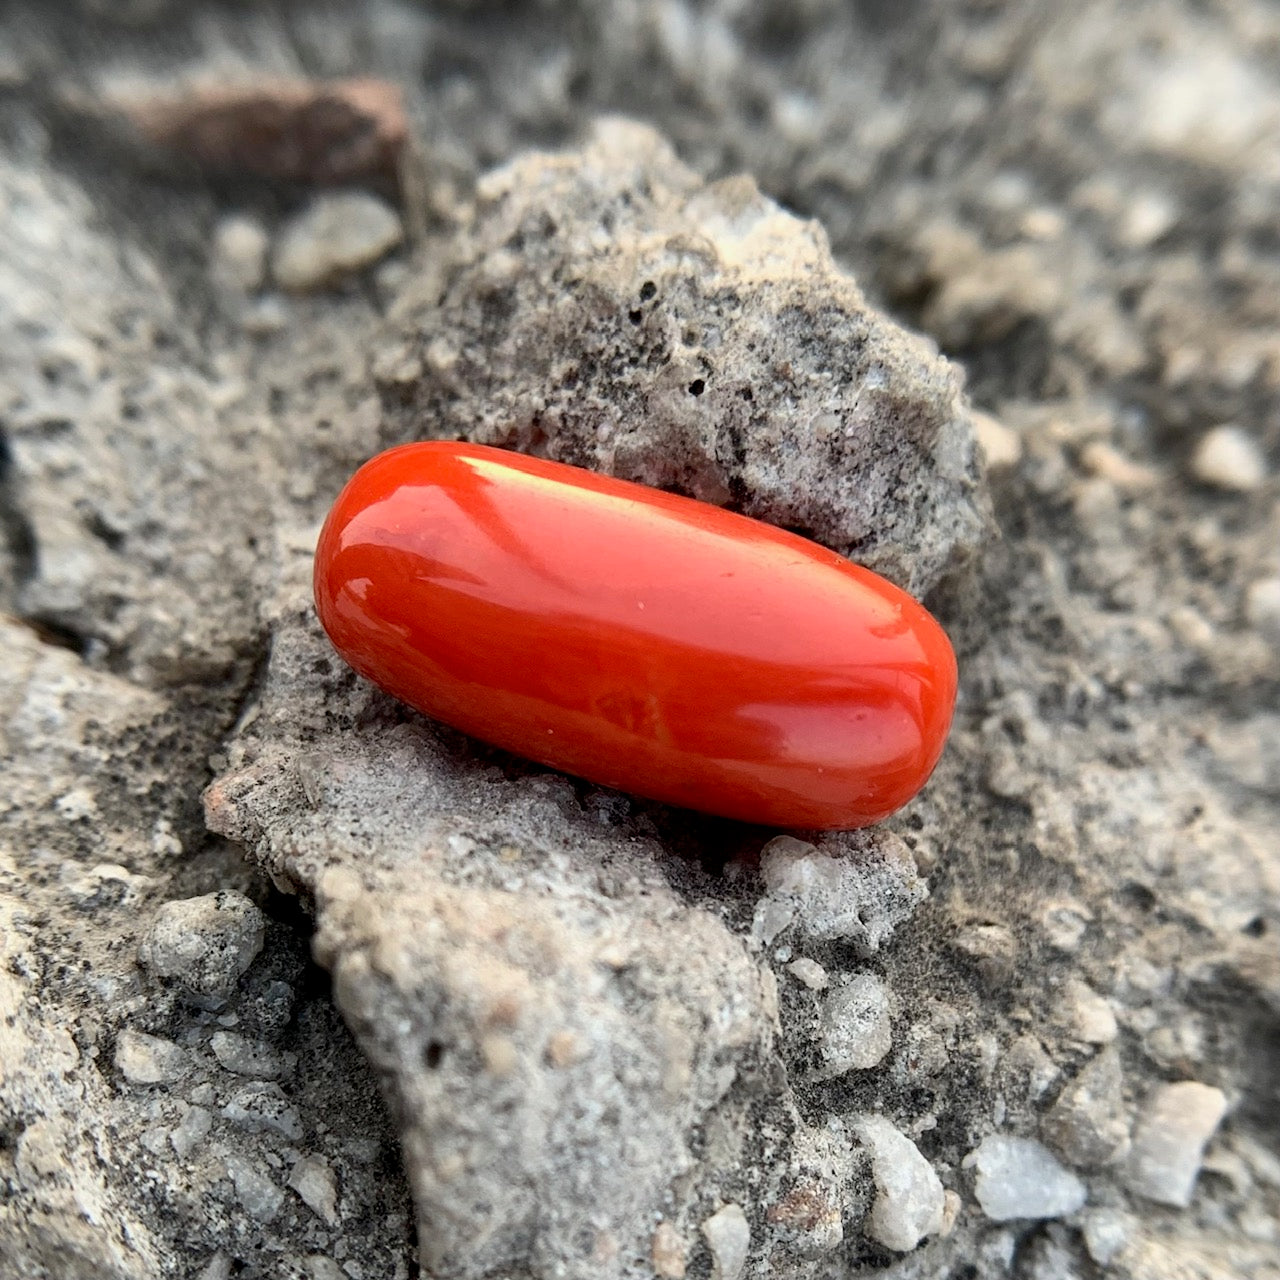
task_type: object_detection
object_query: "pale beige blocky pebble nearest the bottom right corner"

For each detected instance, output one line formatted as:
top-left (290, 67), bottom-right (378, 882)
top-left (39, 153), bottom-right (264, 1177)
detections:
top-left (1125, 1080), bottom-right (1226, 1208)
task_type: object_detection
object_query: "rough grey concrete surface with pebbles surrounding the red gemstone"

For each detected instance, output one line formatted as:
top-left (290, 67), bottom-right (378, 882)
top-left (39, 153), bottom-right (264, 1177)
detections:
top-left (0, 0), bottom-right (1280, 1280)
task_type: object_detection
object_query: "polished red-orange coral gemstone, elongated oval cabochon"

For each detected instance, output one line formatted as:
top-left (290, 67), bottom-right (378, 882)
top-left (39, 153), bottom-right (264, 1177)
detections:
top-left (315, 443), bottom-right (956, 828)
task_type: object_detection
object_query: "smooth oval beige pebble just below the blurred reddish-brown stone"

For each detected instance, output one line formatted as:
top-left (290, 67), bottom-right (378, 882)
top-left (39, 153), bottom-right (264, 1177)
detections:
top-left (271, 191), bottom-right (404, 292)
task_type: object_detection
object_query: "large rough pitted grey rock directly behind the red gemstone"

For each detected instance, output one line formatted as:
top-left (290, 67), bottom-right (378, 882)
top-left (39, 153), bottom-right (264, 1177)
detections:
top-left (376, 120), bottom-right (989, 594)
